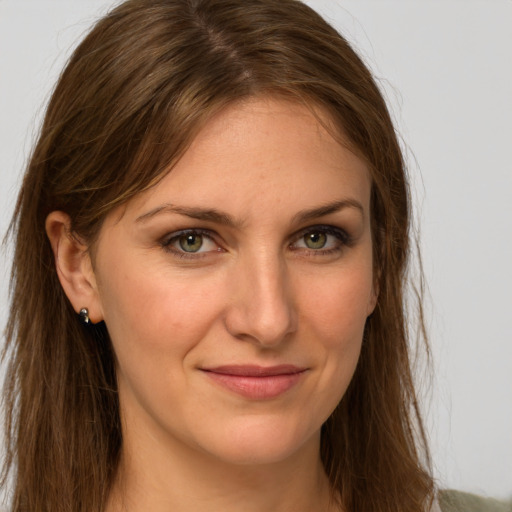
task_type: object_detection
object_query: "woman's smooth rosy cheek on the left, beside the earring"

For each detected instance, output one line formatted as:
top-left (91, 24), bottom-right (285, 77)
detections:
top-left (96, 261), bottom-right (230, 418)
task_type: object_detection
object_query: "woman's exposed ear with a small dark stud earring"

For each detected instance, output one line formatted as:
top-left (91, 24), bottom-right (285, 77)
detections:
top-left (46, 211), bottom-right (103, 323)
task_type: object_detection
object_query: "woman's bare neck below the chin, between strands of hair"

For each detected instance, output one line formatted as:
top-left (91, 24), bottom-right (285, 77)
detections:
top-left (107, 428), bottom-right (340, 512)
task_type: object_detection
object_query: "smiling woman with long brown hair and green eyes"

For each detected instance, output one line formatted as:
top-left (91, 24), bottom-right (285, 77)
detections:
top-left (1, 0), bottom-right (440, 512)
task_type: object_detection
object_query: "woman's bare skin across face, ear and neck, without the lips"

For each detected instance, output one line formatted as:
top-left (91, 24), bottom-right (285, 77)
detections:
top-left (47, 98), bottom-right (377, 512)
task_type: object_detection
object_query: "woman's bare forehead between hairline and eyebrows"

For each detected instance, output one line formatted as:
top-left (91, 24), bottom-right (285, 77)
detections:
top-left (114, 97), bottom-right (370, 224)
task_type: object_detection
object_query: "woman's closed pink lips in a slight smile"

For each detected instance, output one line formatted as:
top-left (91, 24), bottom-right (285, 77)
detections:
top-left (202, 365), bottom-right (306, 400)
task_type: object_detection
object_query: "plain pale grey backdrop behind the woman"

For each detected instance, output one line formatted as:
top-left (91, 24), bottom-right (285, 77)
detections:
top-left (0, 0), bottom-right (512, 498)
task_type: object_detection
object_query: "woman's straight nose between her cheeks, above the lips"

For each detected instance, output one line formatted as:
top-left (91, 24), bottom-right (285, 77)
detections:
top-left (225, 255), bottom-right (298, 348)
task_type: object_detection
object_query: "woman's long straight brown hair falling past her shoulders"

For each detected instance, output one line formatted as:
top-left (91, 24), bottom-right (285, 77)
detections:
top-left (4, 0), bottom-right (433, 512)
